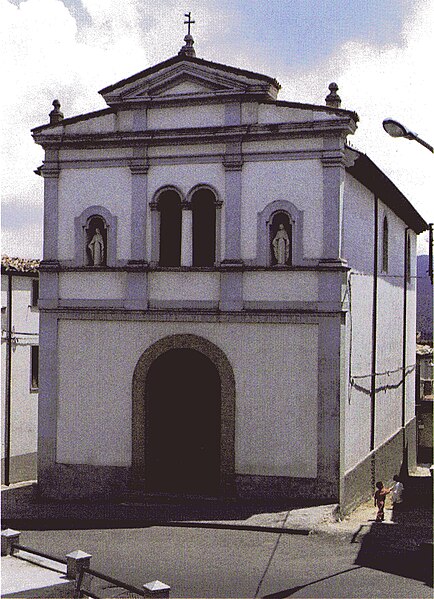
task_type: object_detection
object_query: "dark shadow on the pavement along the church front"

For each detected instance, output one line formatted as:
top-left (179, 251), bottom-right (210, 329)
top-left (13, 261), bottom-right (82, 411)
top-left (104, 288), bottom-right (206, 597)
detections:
top-left (2, 484), bottom-right (324, 534)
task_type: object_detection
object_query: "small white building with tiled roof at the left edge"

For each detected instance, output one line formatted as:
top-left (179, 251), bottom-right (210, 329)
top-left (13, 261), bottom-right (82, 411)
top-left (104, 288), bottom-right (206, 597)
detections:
top-left (1, 256), bottom-right (39, 484)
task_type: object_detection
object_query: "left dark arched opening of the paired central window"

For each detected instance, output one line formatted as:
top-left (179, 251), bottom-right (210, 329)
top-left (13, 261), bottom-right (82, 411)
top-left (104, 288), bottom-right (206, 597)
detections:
top-left (158, 189), bottom-right (182, 266)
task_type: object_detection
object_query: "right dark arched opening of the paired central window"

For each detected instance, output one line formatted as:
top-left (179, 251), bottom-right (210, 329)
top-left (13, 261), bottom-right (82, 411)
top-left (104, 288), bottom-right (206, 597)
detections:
top-left (191, 189), bottom-right (216, 266)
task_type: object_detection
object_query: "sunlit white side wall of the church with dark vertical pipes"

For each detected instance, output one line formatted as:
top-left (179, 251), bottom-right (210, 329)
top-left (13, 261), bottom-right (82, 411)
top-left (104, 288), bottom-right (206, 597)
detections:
top-left (343, 175), bottom-right (416, 510)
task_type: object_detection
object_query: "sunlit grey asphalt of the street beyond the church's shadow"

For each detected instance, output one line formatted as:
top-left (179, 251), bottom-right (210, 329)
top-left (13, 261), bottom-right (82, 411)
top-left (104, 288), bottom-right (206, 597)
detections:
top-left (1, 525), bottom-right (432, 597)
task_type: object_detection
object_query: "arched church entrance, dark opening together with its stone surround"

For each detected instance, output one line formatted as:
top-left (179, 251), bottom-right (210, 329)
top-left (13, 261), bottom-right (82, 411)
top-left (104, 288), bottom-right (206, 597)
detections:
top-left (132, 335), bottom-right (235, 495)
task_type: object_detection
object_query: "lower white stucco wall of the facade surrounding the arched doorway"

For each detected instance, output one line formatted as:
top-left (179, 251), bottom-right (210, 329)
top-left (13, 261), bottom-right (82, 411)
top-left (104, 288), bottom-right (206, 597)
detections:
top-left (57, 320), bottom-right (318, 477)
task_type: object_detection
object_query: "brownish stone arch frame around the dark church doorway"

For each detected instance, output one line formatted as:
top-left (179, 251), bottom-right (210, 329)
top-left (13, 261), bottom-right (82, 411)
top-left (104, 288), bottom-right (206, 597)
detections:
top-left (131, 334), bottom-right (235, 496)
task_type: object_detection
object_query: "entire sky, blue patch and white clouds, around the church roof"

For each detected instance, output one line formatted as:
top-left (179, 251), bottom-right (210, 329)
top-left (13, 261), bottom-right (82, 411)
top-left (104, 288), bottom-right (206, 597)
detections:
top-left (0, 0), bottom-right (434, 258)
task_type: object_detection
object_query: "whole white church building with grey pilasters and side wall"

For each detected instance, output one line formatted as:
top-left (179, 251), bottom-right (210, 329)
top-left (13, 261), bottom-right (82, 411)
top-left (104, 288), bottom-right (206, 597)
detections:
top-left (33, 36), bottom-right (427, 506)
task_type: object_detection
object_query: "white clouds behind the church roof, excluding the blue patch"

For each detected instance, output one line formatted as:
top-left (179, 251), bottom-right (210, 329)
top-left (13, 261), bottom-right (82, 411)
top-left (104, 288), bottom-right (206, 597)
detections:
top-left (0, 0), bottom-right (434, 255)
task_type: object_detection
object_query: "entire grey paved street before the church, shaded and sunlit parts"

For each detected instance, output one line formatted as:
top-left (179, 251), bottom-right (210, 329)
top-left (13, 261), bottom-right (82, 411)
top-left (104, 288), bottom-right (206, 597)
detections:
top-left (2, 478), bottom-right (433, 598)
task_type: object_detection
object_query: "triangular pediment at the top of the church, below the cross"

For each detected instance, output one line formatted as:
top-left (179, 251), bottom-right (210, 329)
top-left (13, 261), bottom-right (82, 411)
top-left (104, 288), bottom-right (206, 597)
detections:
top-left (100, 57), bottom-right (279, 106)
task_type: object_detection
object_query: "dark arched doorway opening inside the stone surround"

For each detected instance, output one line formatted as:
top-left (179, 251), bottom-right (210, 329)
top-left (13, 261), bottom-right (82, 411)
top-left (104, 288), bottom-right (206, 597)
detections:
top-left (145, 349), bottom-right (221, 494)
